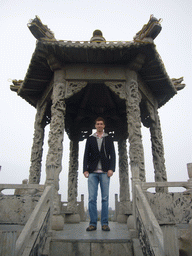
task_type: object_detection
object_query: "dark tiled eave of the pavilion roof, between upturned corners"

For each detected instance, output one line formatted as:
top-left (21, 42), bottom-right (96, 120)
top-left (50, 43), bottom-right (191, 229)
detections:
top-left (11, 40), bottom-right (177, 107)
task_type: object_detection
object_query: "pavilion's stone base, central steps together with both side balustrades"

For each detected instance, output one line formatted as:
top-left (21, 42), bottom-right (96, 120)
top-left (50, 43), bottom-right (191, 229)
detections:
top-left (0, 179), bottom-right (192, 256)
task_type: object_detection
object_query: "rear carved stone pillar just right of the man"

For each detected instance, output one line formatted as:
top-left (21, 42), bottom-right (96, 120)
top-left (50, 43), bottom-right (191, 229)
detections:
top-left (117, 138), bottom-right (131, 223)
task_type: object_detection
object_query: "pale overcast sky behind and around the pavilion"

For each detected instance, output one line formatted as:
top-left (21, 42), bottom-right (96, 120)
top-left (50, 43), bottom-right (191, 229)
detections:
top-left (0, 0), bottom-right (192, 210)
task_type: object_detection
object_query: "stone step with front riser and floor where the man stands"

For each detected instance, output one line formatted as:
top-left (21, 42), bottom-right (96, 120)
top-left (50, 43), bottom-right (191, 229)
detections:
top-left (49, 222), bottom-right (138, 256)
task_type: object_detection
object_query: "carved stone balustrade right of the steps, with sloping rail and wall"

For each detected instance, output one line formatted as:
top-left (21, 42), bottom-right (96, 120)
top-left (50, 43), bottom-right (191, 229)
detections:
top-left (131, 163), bottom-right (192, 255)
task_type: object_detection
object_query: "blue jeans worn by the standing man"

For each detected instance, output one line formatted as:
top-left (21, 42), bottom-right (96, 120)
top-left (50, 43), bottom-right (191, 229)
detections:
top-left (88, 173), bottom-right (110, 226)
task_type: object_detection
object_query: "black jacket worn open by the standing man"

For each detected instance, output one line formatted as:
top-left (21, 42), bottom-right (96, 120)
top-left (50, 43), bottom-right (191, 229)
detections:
top-left (83, 136), bottom-right (115, 173)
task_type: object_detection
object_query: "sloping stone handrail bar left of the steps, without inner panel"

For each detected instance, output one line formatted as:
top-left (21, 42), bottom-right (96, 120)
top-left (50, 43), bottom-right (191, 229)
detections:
top-left (15, 186), bottom-right (52, 256)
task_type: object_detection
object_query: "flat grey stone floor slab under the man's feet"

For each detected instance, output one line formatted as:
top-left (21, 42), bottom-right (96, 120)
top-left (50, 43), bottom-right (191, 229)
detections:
top-left (52, 222), bottom-right (131, 243)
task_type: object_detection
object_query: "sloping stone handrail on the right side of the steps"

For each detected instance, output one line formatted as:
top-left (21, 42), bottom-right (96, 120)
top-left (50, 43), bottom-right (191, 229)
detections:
top-left (135, 183), bottom-right (164, 256)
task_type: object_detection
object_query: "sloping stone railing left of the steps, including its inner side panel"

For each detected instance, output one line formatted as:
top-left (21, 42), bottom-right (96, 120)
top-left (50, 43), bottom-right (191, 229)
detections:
top-left (15, 186), bottom-right (53, 256)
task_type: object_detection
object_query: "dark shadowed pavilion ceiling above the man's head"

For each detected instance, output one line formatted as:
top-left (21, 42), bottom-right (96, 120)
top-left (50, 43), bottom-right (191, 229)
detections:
top-left (65, 83), bottom-right (127, 140)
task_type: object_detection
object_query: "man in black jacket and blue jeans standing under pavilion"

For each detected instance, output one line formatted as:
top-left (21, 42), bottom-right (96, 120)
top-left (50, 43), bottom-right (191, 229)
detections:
top-left (83, 117), bottom-right (115, 231)
